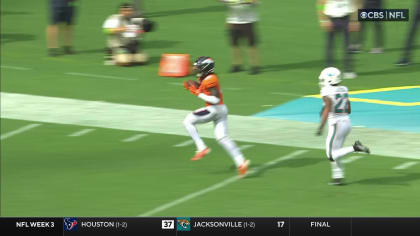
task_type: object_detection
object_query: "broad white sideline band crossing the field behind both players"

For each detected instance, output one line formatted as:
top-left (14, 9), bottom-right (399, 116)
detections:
top-left (0, 92), bottom-right (420, 160)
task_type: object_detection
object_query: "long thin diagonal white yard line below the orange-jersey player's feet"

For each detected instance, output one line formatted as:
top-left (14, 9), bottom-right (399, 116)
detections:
top-left (138, 150), bottom-right (307, 217)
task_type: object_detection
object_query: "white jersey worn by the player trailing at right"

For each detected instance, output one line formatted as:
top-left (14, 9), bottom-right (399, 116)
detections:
top-left (321, 86), bottom-right (349, 125)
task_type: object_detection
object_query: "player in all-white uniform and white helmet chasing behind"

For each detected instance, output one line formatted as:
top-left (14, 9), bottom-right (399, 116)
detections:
top-left (316, 67), bottom-right (370, 185)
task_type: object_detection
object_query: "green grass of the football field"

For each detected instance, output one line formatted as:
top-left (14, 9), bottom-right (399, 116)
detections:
top-left (0, 0), bottom-right (420, 216)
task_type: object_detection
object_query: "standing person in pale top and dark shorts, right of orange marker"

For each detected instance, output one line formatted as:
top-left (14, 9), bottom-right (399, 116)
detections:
top-left (219, 0), bottom-right (260, 74)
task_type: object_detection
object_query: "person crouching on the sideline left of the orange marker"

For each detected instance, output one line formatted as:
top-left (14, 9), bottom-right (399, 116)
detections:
top-left (103, 3), bottom-right (153, 66)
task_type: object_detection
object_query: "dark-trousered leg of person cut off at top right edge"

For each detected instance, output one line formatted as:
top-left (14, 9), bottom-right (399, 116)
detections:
top-left (395, 0), bottom-right (420, 66)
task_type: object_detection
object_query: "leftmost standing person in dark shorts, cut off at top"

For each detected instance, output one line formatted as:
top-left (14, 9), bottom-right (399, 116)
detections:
top-left (46, 0), bottom-right (76, 56)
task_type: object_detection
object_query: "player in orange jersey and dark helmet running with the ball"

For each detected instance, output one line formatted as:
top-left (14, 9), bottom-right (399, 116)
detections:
top-left (184, 57), bottom-right (250, 176)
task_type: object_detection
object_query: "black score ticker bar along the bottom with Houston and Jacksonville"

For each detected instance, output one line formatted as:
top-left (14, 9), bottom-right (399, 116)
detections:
top-left (0, 217), bottom-right (420, 236)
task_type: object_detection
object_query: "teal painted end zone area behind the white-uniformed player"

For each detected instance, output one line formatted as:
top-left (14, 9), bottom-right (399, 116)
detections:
top-left (254, 94), bottom-right (420, 133)
